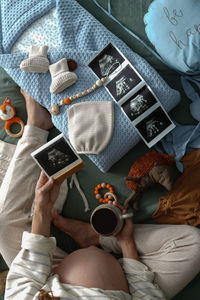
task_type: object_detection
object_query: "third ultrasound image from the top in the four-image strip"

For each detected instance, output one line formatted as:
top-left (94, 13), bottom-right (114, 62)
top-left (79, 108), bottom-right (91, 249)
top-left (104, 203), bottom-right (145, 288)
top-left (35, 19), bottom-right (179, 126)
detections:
top-left (122, 86), bottom-right (157, 121)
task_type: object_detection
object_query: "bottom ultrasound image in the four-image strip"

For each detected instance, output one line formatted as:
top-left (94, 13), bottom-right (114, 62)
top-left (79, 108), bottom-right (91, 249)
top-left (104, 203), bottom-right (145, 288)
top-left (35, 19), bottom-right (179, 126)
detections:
top-left (135, 107), bottom-right (173, 143)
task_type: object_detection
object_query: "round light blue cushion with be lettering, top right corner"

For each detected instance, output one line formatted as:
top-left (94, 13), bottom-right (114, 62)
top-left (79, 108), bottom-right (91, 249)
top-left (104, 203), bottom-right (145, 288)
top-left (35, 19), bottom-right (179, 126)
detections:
top-left (144, 0), bottom-right (200, 75)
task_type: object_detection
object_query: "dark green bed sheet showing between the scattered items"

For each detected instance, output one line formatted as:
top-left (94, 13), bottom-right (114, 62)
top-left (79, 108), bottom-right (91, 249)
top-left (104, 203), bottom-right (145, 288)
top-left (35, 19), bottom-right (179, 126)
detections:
top-left (0, 0), bottom-right (200, 300)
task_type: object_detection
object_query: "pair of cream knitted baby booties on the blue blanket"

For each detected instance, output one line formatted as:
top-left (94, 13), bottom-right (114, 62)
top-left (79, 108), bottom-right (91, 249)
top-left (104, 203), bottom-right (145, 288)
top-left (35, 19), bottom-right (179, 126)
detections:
top-left (20, 46), bottom-right (77, 94)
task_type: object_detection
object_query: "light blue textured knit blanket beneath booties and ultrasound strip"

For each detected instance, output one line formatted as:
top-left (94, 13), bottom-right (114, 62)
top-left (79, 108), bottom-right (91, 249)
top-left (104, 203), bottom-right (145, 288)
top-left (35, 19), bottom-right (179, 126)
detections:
top-left (0, 0), bottom-right (180, 172)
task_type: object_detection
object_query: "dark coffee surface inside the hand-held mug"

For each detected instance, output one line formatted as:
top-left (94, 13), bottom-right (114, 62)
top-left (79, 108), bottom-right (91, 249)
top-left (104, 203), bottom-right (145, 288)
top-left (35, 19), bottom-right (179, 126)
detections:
top-left (91, 208), bottom-right (117, 235)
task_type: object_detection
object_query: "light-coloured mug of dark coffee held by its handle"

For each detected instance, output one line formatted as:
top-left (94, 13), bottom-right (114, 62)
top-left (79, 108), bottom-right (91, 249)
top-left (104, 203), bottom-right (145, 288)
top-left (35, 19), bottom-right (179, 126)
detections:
top-left (90, 204), bottom-right (133, 236)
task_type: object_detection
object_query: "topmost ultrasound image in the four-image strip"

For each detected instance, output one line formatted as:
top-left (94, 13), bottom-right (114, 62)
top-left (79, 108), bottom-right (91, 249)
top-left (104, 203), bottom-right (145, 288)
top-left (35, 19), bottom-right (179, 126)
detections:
top-left (88, 43), bottom-right (125, 78)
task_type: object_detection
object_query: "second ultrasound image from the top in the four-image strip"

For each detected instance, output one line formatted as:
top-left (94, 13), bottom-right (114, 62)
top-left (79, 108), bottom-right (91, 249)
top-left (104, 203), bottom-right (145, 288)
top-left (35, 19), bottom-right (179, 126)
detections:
top-left (106, 65), bottom-right (141, 101)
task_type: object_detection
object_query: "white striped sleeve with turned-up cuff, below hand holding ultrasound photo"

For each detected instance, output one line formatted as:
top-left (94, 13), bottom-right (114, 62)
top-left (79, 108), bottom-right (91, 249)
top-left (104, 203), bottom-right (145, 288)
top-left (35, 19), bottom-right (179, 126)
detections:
top-left (5, 232), bottom-right (56, 300)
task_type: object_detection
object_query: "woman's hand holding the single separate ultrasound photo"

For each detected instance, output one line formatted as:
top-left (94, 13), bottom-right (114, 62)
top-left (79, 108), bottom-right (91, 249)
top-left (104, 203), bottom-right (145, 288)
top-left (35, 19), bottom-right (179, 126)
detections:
top-left (35, 172), bottom-right (61, 215)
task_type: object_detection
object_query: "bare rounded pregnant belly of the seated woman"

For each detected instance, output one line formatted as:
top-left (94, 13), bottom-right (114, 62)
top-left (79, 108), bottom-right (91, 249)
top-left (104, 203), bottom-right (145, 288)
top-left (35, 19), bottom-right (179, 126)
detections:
top-left (54, 246), bottom-right (129, 293)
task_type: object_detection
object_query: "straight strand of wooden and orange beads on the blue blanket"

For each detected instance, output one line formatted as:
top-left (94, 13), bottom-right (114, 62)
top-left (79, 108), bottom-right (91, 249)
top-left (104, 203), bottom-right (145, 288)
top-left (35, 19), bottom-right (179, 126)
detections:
top-left (50, 77), bottom-right (107, 115)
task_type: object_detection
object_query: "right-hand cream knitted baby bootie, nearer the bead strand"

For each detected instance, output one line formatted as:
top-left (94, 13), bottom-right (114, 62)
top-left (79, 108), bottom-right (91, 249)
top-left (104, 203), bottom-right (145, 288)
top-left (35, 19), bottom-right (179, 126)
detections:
top-left (49, 58), bottom-right (77, 94)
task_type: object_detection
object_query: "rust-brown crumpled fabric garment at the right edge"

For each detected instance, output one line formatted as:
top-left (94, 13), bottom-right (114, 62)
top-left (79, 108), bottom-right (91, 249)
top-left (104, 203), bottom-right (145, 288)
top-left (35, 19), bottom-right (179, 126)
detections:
top-left (152, 149), bottom-right (200, 226)
